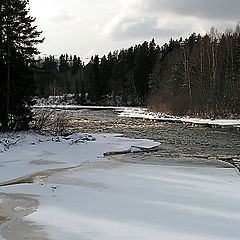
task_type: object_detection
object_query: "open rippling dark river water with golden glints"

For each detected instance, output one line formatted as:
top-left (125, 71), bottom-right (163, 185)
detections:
top-left (41, 109), bottom-right (240, 168)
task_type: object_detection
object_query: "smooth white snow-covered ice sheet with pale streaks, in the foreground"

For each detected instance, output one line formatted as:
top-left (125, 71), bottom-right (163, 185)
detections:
top-left (5, 162), bottom-right (240, 240)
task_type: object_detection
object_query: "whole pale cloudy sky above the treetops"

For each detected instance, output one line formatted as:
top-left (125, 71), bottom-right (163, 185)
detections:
top-left (30, 0), bottom-right (240, 57)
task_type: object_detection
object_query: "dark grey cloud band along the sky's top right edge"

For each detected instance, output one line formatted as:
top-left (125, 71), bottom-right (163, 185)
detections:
top-left (131, 0), bottom-right (240, 21)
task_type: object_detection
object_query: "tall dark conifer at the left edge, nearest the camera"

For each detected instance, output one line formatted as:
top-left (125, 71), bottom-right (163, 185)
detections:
top-left (0, 0), bottom-right (43, 130)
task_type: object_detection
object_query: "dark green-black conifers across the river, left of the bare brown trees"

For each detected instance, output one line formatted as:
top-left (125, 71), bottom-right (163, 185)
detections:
top-left (35, 39), bottom-right (159, 105)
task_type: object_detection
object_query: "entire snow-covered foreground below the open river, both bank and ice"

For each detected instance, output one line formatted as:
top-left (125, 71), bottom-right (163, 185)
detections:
top-left (0, 133), bottom-right (240, 240)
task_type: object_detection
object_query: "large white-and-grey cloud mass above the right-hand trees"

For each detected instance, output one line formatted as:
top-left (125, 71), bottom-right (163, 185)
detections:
top-left (105, 0), bottom-right (240, 41)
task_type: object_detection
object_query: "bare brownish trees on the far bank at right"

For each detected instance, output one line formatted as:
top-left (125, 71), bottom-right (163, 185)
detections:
top-left (149, 25), bottom-right (240, 117)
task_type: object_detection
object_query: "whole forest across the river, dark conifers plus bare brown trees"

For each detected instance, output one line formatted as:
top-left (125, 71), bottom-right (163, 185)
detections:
top-left (35, 24), bottom-right (240, 117)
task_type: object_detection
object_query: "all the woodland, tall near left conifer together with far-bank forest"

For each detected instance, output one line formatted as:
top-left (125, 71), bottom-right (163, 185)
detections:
top-left (0, 0), bottom-right (240, 130)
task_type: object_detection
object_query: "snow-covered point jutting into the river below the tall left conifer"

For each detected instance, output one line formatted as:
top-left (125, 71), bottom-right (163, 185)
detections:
top-left (0, 133), bottom-right (158, 182)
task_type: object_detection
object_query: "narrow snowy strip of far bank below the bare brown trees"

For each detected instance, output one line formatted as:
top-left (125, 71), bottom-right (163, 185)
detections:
top-left (119, 108), bottom-right (240, 128)
